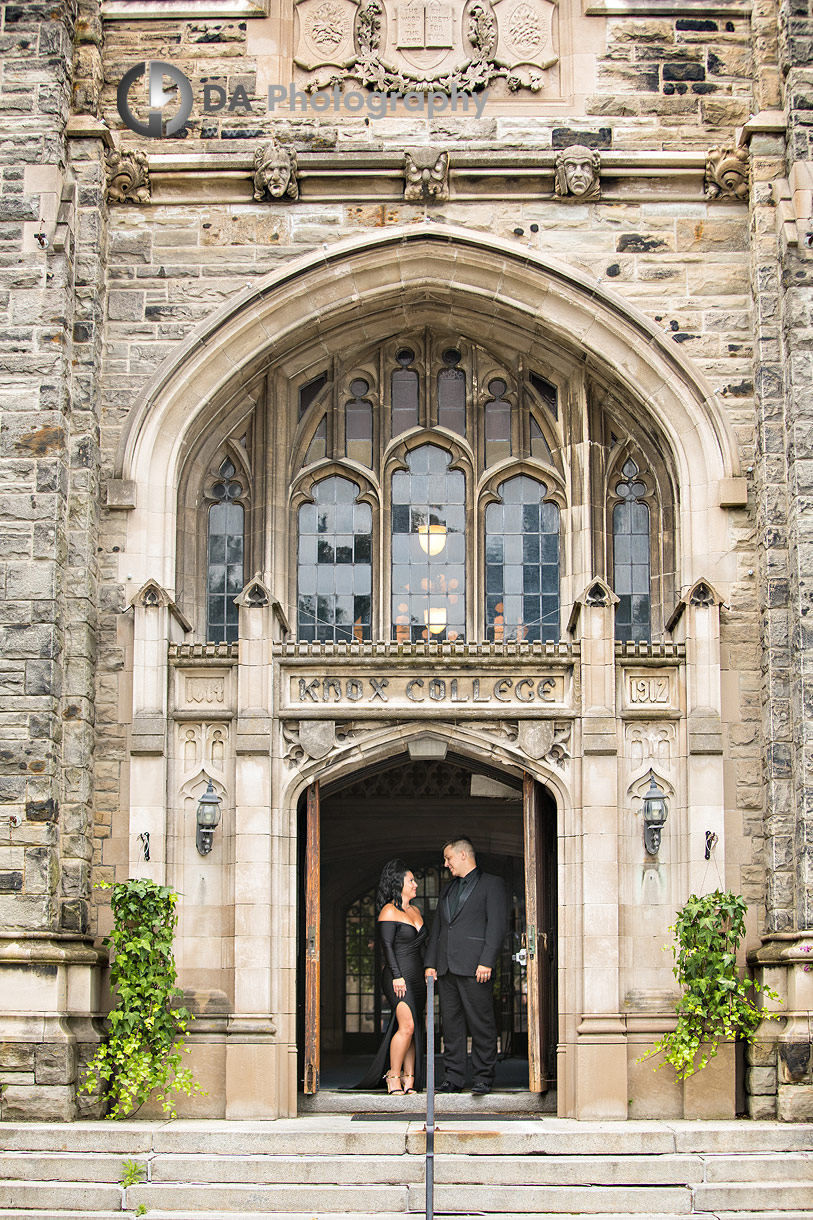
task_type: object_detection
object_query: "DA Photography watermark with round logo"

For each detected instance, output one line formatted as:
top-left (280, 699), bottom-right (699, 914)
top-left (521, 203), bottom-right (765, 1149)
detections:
top-left (116, 60), bottom-right (488, 139)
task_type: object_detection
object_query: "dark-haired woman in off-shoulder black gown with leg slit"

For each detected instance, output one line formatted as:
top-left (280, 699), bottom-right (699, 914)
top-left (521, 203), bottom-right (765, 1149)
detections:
top-left (356, 860), bottom-right (426, 1093)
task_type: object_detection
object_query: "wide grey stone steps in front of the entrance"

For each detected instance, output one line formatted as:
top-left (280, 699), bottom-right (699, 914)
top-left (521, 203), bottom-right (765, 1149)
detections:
top-left (0, 1115), bottom-right (813, 1220)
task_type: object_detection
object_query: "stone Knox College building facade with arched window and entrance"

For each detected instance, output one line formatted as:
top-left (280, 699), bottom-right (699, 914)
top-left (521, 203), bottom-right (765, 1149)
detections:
top-left (0, 0), bottom-right (813, 1120)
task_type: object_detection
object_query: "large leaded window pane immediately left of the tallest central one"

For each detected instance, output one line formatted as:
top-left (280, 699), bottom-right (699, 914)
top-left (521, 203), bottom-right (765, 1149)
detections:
top-left (297, 476), bottom-right (372, 641)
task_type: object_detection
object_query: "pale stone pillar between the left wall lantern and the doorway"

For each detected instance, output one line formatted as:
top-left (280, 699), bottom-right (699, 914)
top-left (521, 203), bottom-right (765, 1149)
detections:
top-left (226, 577), bottom-right (277, 1119)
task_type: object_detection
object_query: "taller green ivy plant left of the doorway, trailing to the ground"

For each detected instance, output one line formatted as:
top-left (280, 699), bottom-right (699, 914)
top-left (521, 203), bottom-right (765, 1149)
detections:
top-left (82, 880), bottom-right (203, 1119)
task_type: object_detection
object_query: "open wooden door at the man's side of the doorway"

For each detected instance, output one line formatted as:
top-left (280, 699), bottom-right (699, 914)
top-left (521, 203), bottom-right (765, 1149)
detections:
top-left (522, 775), bottom-right (555, 1093)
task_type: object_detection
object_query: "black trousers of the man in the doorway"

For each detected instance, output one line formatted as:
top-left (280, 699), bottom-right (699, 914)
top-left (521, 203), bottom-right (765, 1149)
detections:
top-left (437, 972), bottom-right (497, 1087)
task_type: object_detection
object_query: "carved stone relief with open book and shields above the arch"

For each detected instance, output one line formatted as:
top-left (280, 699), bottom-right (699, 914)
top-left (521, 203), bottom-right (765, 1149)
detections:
top-left (294, 0), bottom-right (559, 93)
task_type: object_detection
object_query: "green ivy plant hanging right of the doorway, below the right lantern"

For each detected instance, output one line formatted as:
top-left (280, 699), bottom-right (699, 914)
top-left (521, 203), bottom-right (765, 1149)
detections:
top-left (643, 889), bottom-right (779, 1080)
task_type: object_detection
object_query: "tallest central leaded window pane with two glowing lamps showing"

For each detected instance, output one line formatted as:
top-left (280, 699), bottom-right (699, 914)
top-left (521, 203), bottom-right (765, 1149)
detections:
top-left (392, 445), bottom-right (466, 642)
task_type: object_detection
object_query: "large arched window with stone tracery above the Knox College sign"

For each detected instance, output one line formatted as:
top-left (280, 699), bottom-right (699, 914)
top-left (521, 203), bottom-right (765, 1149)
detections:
top-left (179, 329), bottom-right (678, 642)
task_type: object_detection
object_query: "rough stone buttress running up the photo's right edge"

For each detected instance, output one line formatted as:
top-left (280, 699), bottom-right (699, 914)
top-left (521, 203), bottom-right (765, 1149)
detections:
top-left (746, 0), bottom-right (813, 1120)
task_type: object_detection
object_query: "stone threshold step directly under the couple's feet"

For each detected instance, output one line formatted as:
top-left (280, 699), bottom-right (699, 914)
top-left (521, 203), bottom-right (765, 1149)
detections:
top-left (297, 1088), bottom-right (557, 1119)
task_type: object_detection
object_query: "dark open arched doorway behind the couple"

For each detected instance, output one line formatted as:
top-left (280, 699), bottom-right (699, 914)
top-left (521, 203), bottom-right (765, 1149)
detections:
top-left (298, 755), bottom-right (558, 1092)
